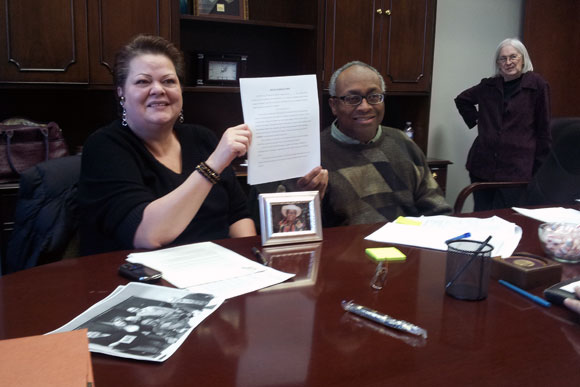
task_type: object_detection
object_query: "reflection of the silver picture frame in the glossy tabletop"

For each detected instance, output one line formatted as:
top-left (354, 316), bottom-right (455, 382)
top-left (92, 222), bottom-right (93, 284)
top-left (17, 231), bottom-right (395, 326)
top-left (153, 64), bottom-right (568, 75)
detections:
top-left (260, 242), bottom-right (322, 291)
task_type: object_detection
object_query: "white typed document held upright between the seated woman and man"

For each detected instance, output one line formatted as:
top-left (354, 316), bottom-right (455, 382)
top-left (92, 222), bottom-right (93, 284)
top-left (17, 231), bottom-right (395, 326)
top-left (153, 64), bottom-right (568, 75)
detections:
top-left (240, 75), bottom-right (320, 185)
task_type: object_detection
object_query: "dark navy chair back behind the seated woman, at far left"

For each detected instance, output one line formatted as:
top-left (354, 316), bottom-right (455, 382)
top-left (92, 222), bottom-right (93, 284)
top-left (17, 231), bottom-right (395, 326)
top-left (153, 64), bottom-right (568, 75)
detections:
top-left (6, 155), bottom-right (81, 273)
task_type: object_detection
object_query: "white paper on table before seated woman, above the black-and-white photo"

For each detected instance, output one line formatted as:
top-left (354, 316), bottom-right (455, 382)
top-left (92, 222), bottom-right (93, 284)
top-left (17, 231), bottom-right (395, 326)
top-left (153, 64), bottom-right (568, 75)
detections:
top-left (127, 242), bottom-right (294, 298)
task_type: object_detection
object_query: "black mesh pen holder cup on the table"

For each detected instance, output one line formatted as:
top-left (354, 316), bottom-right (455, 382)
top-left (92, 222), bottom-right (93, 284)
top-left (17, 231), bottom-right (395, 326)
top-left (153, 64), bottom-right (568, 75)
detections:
top-left (445, 239), bottom-right (493, 300)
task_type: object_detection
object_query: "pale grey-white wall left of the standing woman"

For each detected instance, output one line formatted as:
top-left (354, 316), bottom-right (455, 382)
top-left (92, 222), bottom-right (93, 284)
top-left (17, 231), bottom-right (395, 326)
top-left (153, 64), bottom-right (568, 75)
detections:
top-left (427, 0), bottom-right (524, 211)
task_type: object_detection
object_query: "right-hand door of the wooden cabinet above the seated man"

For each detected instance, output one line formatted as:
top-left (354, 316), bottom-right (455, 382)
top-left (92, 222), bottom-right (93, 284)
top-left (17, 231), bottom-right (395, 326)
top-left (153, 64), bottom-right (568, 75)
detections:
top-left (378, 0), bottom-right (436, 92)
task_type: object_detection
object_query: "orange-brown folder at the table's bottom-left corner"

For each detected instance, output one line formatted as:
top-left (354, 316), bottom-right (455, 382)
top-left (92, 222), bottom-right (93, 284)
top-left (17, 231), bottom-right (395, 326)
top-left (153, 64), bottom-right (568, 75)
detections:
top-left (0, 329), bottom-right (94, 387)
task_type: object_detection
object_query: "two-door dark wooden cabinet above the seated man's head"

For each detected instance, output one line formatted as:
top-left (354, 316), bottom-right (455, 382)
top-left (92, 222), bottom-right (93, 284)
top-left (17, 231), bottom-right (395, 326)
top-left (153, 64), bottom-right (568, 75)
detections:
top-left (324, 0), bottom-right (436, 92)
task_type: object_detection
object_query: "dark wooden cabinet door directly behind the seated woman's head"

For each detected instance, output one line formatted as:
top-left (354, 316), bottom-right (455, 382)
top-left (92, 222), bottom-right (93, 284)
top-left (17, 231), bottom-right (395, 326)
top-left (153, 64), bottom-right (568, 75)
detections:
top-left (88, 0), bottom-right (172, 85)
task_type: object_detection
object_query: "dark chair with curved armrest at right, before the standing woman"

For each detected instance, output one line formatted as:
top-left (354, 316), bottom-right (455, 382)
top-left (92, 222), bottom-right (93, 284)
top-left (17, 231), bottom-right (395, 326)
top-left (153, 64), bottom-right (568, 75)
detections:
top-left (453, 117), bottom-right (580, 214)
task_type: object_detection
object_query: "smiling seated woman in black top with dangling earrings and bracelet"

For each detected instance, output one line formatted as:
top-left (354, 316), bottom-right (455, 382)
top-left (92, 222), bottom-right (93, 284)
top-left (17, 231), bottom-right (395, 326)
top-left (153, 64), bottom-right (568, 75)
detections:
top-left (79, 35), bottom-right (256, 255)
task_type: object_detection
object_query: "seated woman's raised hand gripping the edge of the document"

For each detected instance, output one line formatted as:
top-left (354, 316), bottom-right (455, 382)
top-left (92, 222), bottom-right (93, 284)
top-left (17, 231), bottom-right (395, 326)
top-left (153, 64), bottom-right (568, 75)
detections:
top-left (206, 124), bottom-right (252, 173)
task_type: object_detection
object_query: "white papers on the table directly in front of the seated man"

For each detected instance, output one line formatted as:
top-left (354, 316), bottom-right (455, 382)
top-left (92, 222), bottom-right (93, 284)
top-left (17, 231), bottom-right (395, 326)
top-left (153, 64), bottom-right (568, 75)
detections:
top-left (365, 215), bottom-right (522, 258)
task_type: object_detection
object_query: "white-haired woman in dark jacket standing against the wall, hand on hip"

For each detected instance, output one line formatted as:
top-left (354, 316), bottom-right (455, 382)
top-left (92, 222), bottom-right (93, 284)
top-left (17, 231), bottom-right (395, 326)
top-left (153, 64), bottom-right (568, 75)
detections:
top-left (455, 38), bottom-right (552, 211)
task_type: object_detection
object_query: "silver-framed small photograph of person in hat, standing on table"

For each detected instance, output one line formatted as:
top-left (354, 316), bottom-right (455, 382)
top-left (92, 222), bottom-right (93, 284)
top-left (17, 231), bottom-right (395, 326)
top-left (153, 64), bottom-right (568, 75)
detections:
top-left (258, 191), bottom-right (322, 246)
